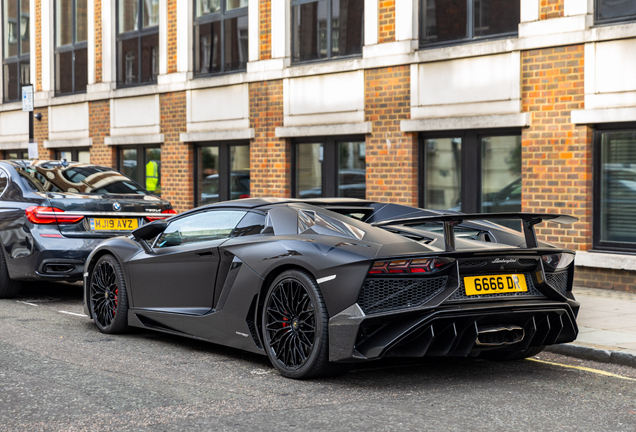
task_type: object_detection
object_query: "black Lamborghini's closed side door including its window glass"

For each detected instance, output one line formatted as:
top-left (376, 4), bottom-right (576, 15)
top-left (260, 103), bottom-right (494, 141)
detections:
top-left (128, 209), bottom-right (246, 315)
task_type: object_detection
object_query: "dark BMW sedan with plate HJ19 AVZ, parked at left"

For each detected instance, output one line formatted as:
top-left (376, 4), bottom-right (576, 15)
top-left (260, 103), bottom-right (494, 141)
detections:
top-left (0, 160), bottom-right (176, 298)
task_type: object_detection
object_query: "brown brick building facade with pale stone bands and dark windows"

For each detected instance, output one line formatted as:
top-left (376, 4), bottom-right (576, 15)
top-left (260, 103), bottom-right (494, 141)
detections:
top-left (0, 0), bottom-right (636, 291)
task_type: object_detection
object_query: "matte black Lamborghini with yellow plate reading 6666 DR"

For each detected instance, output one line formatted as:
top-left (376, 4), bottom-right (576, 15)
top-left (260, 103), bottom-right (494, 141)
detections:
top-left (84, 198), bottom-right (579, 378)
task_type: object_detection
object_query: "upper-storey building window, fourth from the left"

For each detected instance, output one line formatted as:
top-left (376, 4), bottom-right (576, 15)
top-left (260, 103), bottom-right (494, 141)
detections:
top-left (194, 0), bottom-right (248, 75)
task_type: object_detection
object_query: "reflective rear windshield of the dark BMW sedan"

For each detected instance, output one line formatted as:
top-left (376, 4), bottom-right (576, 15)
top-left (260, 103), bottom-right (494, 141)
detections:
top-left (15, 161), bottom-right (149, 195)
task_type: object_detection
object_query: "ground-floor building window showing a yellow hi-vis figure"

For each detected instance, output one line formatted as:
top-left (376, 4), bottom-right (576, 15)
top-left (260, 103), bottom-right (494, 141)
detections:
top-left (118, 144), bottom-right (161, 196)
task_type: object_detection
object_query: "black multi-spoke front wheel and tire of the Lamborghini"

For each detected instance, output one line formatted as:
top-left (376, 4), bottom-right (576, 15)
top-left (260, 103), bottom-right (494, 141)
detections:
top-left (89, 255), bottom-right (128, 334)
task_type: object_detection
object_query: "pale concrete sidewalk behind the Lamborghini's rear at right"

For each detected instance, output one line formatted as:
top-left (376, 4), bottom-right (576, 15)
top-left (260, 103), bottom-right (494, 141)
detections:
top-left (546, 287), bottom-right (636, 367)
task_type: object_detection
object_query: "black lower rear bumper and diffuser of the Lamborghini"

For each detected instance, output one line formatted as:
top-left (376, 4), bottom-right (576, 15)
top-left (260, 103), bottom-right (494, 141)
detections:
top-left (329, 299), bottom-right (579, 363)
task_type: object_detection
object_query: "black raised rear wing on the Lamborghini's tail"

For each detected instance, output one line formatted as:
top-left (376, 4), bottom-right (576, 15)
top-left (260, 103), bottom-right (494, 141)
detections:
top-left (371, 213), bottom-right (579, 252)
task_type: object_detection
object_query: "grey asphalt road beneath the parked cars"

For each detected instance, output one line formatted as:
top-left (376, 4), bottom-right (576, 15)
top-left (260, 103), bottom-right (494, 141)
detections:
top-left (0, 283), bottom-right (636, 432)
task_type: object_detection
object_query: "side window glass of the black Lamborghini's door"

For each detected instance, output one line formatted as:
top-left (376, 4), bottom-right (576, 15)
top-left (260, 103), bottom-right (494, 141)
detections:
top-left (156, 210), bottom-right (246, 248)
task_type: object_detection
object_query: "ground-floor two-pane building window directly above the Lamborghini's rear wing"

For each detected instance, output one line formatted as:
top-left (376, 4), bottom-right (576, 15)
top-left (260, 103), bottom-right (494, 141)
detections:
top-left (420, 130), bottom-right (521, 213)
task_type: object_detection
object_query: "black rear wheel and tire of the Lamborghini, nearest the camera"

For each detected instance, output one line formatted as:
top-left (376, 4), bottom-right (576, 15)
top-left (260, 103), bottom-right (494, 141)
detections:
top-left (261, 270), bottom-right (346, 379)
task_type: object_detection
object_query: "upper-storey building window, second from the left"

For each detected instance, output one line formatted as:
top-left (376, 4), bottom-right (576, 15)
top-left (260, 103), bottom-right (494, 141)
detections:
top-left (55, 0), bottom-right (88, 95)
